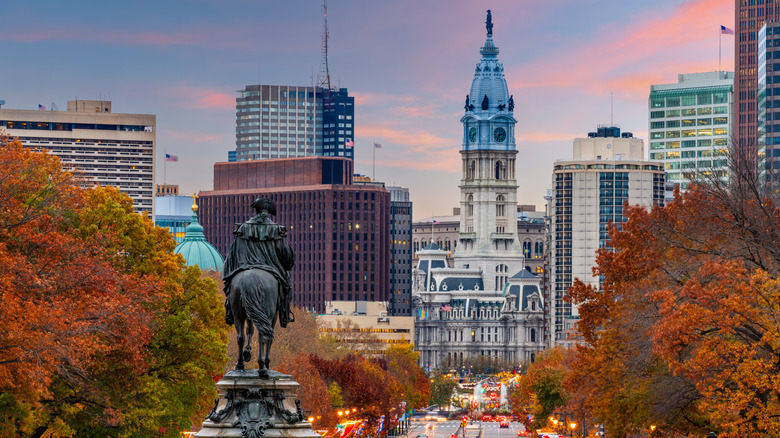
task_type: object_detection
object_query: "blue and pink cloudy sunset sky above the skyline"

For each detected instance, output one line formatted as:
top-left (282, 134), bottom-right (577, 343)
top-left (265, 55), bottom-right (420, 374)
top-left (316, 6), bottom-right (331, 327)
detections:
top-left (0, 0), bottom-right (734, 218)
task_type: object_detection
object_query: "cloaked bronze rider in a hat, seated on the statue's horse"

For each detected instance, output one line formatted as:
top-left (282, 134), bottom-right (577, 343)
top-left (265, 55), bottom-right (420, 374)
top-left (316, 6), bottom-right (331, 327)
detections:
top-left (222, 198), bottom-right (295, 327)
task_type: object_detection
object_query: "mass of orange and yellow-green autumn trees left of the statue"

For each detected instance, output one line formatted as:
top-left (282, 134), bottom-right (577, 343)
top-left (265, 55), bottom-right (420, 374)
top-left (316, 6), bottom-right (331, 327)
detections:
top-left (0, 138), bottom-right (225, 437)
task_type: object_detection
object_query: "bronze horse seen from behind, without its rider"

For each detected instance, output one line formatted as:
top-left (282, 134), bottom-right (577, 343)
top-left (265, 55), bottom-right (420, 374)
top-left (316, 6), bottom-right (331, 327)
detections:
top-left (228, 269), bottom-right (279, 378)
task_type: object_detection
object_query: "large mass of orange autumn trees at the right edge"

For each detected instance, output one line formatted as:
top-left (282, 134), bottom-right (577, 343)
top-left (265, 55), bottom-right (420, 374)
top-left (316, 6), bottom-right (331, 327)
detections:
top-left (567, 157), bottom-right (780, 436)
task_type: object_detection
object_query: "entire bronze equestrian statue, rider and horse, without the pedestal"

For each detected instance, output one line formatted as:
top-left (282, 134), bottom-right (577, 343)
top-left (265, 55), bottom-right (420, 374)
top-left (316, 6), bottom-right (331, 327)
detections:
top-left (222, 198), bottom-right (295, 377)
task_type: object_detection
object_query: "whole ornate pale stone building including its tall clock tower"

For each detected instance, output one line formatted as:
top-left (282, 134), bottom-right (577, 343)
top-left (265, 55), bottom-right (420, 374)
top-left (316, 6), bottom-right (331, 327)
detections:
top-left (413, 11), bottom-right (545, 370)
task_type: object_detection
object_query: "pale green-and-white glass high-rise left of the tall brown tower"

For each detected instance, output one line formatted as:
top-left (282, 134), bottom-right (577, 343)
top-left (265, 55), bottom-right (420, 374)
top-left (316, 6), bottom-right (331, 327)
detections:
top-left (649, 71), bottom-right (734, 190)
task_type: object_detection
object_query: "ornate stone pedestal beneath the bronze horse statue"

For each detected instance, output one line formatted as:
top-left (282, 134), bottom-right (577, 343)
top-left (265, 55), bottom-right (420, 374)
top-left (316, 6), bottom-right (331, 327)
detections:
top-left (195, 370), bottom-right (320, 438)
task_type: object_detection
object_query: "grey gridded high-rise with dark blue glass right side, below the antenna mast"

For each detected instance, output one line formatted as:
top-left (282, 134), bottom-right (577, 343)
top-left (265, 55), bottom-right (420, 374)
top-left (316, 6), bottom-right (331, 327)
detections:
top-left (229, 85), bottom-right (355, 161)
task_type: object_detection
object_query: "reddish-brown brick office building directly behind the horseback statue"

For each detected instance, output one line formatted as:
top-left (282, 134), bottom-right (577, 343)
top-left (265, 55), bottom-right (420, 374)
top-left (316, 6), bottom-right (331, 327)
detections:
top-left (198, 157), bottom-right (390, 313)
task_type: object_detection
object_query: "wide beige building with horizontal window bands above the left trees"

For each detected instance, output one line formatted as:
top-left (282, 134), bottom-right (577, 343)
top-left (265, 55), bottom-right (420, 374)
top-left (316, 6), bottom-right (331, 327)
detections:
top-left (0, 100), bottom-right (157, 214)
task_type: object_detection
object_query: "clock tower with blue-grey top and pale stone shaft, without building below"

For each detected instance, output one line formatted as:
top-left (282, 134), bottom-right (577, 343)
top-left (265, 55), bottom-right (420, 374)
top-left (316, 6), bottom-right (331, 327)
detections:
top-left (453, 10), bottom-right (524, 291)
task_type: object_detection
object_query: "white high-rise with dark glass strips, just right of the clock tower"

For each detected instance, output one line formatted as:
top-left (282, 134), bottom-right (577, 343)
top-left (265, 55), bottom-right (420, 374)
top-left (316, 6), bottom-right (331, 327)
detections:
top-left (548, 126), bottom-right (664, 346)
